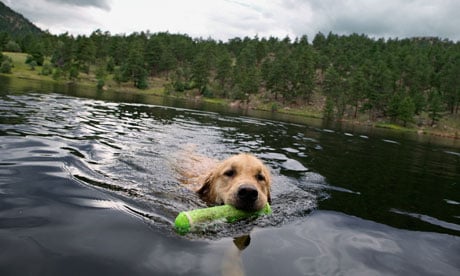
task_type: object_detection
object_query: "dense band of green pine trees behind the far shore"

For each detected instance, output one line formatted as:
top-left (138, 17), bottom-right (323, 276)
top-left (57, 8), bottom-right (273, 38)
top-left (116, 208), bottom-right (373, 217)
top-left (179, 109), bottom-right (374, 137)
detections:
top-left (0, 30), bottom-right (460, 124)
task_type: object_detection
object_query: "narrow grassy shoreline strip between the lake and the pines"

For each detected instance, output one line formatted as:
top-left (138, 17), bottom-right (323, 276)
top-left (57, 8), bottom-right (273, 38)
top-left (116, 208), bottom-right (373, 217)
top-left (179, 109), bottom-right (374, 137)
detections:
top-left (0, 52), bottom-right (460, 140)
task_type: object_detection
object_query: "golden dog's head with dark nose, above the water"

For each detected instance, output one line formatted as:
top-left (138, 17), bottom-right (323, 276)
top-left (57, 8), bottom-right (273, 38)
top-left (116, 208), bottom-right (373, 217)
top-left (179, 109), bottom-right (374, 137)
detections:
top-left (198, 154), bottom-right (271, 211)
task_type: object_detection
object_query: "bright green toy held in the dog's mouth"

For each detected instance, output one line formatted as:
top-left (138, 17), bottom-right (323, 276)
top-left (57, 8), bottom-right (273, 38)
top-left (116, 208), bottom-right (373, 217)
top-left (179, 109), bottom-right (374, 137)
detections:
top-left (174, 203), bottom-right (272, 235)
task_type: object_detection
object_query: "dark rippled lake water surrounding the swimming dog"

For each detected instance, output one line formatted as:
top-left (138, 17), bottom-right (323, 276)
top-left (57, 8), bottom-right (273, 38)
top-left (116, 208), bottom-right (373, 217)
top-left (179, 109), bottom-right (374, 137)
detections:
top-left (0, 78), bottom-right (460, 275)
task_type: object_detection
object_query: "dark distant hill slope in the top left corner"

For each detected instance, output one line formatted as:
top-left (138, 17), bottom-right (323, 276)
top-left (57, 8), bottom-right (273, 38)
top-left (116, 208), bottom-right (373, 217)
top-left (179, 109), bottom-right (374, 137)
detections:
top-left (0, 2), bottom-right (43, 37)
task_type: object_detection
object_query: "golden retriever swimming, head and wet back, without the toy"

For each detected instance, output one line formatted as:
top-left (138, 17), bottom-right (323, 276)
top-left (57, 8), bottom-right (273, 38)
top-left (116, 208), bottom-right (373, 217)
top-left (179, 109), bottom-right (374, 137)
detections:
top-left (176, 152), bottom-right (271, 211)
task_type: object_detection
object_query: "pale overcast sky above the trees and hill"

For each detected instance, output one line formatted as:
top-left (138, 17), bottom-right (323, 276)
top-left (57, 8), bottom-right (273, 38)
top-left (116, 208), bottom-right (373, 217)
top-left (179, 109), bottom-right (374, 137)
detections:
top-left (0, 0), bottom-right (460, 41)
